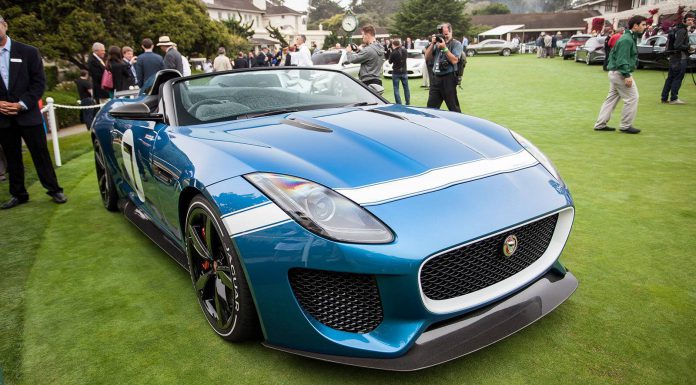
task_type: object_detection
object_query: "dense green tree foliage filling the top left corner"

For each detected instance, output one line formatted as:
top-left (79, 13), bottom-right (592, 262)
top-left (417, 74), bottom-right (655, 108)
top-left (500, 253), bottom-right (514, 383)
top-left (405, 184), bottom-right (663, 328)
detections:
top-left (0, 0), bottom-right (237, 68)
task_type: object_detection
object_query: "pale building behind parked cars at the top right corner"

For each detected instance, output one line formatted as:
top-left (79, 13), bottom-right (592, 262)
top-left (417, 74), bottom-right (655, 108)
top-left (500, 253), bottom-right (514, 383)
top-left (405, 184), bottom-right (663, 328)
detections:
top-left (573, 0), bottom-right (696, 28)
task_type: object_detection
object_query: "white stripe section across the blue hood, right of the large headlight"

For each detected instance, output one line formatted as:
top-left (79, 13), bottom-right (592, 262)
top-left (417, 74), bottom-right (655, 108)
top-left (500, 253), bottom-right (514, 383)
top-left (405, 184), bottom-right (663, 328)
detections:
top-left (336, 150), bottom-right (539, 206)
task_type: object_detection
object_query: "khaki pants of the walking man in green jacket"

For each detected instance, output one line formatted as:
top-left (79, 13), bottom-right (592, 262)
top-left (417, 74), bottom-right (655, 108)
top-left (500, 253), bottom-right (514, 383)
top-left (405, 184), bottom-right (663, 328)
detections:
top-left (595, 71), bottom-right (638, 130)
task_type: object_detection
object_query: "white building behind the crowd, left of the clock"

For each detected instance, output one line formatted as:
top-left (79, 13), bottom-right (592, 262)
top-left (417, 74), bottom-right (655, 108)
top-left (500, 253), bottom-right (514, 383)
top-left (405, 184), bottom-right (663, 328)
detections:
top-left (201, 0), bottom-right (330, 47)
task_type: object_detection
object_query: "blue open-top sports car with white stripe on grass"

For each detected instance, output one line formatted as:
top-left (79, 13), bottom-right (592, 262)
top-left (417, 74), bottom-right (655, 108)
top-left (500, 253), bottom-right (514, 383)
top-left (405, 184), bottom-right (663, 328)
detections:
top-left (92, 67), bottom-right (577, 370)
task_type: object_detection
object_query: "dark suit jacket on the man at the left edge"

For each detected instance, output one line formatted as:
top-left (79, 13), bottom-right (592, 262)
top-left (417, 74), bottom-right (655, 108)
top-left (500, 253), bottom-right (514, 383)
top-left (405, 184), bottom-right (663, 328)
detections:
top-left (0, 40), bottom-right (46, 128)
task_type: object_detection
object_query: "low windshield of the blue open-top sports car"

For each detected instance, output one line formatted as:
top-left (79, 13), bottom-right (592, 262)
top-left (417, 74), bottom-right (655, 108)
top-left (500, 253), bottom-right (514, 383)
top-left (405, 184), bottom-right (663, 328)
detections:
top-left (172, 69), bottom-right (384, 125)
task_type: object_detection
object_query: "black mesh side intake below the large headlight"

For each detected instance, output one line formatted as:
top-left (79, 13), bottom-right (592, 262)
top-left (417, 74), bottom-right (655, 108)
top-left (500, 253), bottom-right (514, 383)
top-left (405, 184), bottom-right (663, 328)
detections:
top-left (289, 269), bottom-right (384, 333)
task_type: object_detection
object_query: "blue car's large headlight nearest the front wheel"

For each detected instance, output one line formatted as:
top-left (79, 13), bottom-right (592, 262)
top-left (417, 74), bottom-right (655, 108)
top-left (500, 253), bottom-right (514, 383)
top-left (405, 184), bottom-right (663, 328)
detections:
top-left (244, 173), bottom-right (394, 243)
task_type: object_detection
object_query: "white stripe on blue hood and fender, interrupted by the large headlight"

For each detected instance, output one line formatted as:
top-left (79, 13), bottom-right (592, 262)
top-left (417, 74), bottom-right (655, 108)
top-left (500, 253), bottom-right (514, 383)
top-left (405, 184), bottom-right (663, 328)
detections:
top-left (222, 150), bottom-right (538, 237)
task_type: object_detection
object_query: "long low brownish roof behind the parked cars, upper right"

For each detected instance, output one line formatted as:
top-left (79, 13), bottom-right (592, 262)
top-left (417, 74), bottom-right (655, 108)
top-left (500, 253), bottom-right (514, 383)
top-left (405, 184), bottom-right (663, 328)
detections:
top-left (471, 10), bottom-right (599, 30)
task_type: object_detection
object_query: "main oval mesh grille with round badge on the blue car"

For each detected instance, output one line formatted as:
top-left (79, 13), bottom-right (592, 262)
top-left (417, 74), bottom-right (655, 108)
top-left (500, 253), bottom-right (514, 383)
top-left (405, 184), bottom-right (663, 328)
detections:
top-left (420, 214), bottom-right (558, 300)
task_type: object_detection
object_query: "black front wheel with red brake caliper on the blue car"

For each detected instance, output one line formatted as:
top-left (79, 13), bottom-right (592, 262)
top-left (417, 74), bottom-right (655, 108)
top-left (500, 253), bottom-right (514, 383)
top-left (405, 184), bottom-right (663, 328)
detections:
top-left (186, 195), bottom-right (258, 342)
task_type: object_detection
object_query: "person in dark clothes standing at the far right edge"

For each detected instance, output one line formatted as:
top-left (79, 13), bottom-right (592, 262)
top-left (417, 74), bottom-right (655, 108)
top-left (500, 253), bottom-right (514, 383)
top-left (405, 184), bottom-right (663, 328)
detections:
top-left (662, 13), bottom-right (694, 104)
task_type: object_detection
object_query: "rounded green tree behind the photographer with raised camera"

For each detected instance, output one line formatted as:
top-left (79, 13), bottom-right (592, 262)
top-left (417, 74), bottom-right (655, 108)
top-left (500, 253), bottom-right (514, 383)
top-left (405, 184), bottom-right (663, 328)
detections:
top-left (389, 0), bottom-right (471, 38)
